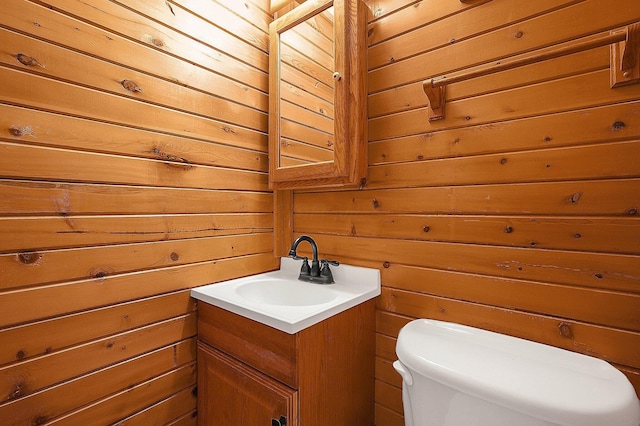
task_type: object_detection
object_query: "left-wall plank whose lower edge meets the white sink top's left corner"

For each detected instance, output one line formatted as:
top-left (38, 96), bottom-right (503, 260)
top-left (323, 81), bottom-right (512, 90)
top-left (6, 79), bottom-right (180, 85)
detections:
top-left (0, 253), bottom-right (276, 327)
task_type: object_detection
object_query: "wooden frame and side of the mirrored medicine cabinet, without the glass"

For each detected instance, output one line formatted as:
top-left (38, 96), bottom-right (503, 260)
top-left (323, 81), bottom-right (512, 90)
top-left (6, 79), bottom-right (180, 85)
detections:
top-left (269, 0), bottom-right (367, 189)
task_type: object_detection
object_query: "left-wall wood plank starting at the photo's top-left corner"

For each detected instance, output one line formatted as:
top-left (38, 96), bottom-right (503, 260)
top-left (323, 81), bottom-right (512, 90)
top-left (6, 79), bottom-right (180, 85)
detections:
top-left (0, 0), bottom-right (268, 112)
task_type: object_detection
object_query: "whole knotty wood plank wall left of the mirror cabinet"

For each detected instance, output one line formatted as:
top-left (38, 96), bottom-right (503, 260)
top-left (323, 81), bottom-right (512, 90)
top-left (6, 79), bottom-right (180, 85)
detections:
top-left (0, 0), bottom-right (276, 425)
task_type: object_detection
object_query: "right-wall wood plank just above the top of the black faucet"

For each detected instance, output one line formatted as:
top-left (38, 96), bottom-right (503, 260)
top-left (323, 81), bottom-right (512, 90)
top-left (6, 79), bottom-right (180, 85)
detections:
top-left (296, 214), bottom-right (640, 254)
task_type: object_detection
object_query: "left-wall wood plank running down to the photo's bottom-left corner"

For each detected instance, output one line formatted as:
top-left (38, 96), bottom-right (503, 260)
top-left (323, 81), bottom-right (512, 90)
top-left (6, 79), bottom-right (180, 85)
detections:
top-left (0, 337), bottom-right (196, 426)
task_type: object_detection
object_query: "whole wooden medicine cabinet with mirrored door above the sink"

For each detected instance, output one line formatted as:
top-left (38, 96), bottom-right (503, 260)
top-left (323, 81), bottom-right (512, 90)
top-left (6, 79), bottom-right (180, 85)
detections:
top-left (269, 0), bottom-right (367, 189)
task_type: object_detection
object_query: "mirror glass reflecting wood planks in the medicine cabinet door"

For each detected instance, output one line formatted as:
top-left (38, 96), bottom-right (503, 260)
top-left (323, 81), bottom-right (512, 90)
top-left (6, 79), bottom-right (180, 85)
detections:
top-left (278, 6), bottom-right (340, 168)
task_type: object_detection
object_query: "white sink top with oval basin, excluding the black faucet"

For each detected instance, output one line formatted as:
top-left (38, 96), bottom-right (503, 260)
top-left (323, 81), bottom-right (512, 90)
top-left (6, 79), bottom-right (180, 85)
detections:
top-left (191, 257), bottom-right (380, 334)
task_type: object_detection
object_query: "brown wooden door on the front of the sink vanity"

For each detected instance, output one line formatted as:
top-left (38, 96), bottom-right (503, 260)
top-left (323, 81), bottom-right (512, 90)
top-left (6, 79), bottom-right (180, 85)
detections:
top-left (198, 342), bottom-right (298, 426)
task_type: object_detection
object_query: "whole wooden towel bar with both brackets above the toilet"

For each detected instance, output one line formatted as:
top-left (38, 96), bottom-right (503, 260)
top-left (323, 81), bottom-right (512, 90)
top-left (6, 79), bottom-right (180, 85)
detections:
top-left (422, 22), bottom-right (640, 121)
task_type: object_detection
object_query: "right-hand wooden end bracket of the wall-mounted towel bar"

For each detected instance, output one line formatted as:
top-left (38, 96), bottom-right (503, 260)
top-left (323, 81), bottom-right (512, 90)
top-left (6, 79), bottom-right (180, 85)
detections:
top-left (609, 23), bottom-right (640, 88)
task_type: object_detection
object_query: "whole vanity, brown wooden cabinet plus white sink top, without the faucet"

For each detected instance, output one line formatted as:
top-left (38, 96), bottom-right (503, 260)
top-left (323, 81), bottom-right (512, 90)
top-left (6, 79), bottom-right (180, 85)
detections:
top-left (191, 258), bottom-right (380, 426)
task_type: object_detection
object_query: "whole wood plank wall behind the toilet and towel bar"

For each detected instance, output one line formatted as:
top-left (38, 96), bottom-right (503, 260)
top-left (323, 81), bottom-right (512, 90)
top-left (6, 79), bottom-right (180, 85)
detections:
top-left (293, 0), bottom-right (640, 426)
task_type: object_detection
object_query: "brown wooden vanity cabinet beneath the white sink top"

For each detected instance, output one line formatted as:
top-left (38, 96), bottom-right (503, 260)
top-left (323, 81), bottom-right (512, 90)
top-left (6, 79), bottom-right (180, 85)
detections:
top-left (198, 300), bottom-right (375, 426)
